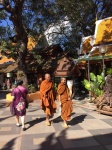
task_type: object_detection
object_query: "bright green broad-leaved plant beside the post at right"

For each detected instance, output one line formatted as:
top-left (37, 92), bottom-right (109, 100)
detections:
top-left (82, 73), bottom-right (104, 96)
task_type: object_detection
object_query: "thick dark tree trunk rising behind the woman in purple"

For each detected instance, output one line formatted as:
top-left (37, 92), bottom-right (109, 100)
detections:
top-left (7, 0), bottom-right (28, 87)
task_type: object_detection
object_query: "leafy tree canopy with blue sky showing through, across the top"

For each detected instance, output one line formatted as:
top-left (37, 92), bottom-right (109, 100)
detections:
top-left (0, 0), bottom-right (112, 85)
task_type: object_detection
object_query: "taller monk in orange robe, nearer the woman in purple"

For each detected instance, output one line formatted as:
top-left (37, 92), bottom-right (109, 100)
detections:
top-left (40, 74), bottom-right (56, 126)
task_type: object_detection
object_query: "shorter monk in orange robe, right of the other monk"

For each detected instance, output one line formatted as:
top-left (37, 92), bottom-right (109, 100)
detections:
top-left (57, 78), bottom-right (73, 128)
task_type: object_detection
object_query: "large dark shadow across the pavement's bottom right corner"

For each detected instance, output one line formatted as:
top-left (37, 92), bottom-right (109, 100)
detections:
top-left (37, 130), bottom-right (112, 150)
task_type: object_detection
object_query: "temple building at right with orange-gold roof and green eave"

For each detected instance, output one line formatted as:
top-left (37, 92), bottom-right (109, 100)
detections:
top-left (76, 17), bottom-right (112, 77)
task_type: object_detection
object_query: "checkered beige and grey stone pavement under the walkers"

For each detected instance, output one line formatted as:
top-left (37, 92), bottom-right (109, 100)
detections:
top-left (0, 96), bottom-right (112, 150)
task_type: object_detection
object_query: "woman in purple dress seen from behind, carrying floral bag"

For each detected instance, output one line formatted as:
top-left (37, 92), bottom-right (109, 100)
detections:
top-left (11, 80), bottom-right (28, 131)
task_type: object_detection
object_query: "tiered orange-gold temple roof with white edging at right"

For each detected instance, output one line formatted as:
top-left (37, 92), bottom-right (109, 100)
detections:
top-left (82, 17), bottom-right (112, 56)
